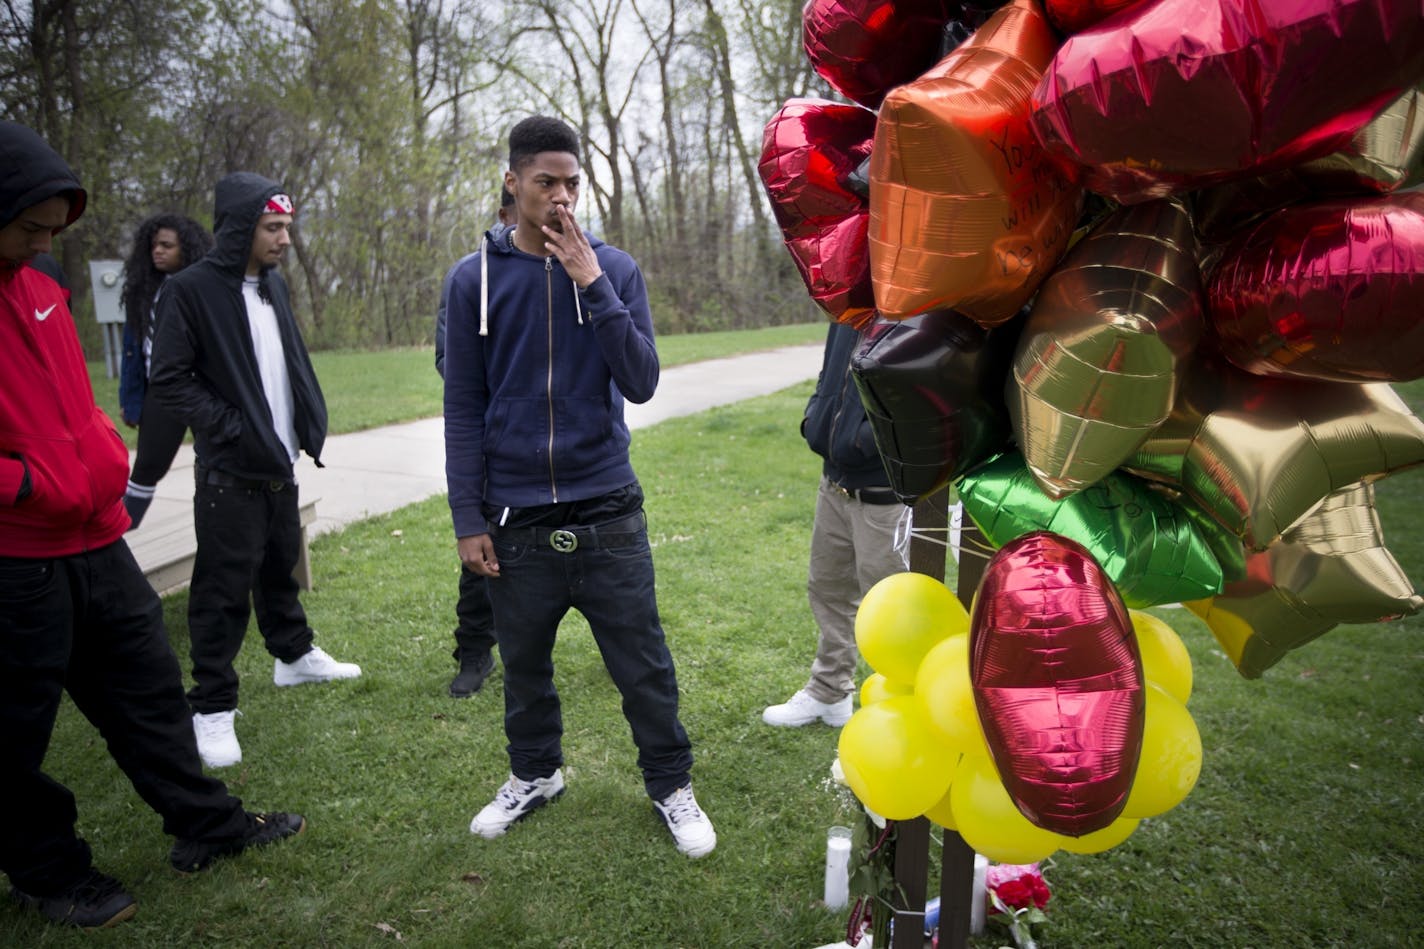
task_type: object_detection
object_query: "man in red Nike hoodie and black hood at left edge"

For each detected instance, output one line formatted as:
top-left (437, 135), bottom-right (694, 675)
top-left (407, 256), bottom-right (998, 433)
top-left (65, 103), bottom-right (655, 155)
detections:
top-left (0, 121), bottom-right (305, 928)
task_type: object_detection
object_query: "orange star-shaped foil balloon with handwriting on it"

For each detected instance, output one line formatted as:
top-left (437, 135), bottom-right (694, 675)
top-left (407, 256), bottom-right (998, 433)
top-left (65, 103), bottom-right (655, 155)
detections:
top-left (870, 0), bottom-right (1082, 326)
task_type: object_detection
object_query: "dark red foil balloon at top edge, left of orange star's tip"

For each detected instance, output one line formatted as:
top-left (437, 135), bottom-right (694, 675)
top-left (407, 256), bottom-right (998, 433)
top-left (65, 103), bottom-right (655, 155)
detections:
top-left (802, 0), bottom-right (960, 108)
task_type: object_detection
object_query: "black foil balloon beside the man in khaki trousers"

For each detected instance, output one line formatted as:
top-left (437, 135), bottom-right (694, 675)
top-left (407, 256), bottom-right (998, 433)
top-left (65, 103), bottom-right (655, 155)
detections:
top-left (850, 309), bottom-right (1022, 504)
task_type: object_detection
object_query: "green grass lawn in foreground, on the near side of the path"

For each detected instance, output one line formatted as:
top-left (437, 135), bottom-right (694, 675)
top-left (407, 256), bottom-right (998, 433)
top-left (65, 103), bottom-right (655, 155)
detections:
top-left (16, 360), bottom-right (1424, 949)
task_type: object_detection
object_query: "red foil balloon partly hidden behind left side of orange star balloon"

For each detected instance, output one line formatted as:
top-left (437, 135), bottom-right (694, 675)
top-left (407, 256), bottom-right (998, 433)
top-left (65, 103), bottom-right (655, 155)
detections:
top-left (758, 98), bottom-right (876, 326)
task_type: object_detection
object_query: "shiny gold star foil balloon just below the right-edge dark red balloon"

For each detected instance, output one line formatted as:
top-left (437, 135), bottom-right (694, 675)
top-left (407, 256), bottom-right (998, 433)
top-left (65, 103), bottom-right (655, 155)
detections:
top-left (1125, 358), bottom-right (1424, 550)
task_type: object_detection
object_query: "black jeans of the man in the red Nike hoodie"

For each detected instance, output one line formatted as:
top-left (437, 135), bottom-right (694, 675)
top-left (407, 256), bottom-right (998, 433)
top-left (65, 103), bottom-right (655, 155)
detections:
top-left (0, 540), bottom-right (244, 896)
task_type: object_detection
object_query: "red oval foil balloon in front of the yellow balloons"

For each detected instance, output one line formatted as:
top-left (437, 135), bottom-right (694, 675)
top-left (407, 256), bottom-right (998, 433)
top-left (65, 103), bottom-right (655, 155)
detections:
top-left (970, 531), bottom-right (1146, 836)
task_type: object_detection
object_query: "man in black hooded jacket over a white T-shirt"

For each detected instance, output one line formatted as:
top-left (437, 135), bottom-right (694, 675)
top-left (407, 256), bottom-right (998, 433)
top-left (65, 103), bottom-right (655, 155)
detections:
top-left (150, 172), bottom-right (360, 768)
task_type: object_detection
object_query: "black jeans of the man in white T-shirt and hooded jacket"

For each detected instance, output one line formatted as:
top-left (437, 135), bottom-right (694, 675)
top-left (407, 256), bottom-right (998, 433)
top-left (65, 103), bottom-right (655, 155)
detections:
top-left (188, 467), bottom-right (313, 714)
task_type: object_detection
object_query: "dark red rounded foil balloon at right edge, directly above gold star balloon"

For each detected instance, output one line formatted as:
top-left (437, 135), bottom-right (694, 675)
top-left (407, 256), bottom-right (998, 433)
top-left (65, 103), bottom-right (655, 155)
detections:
top-left (1208, 192), bottom-right (1424, 382)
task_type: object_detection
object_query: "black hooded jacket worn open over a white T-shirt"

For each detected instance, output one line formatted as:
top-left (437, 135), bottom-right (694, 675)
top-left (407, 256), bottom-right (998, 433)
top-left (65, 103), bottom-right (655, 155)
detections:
top-left (148, 171), bottom-right (326, 482)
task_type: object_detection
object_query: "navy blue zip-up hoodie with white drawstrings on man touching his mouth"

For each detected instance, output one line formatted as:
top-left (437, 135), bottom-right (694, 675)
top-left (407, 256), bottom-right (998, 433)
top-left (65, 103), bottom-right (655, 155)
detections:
top-left (444, 219), bottom-right (659, 537)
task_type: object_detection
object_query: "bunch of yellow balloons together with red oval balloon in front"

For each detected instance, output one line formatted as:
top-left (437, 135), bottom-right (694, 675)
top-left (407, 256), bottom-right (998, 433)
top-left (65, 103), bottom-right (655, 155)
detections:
top-left (839, 558), bottom-right (1202, 864)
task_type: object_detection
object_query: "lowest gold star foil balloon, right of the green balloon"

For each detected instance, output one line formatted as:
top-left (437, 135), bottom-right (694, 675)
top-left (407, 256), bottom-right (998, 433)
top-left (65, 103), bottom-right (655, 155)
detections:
top-left (1186, 483), bottom-right (1424, 678)
